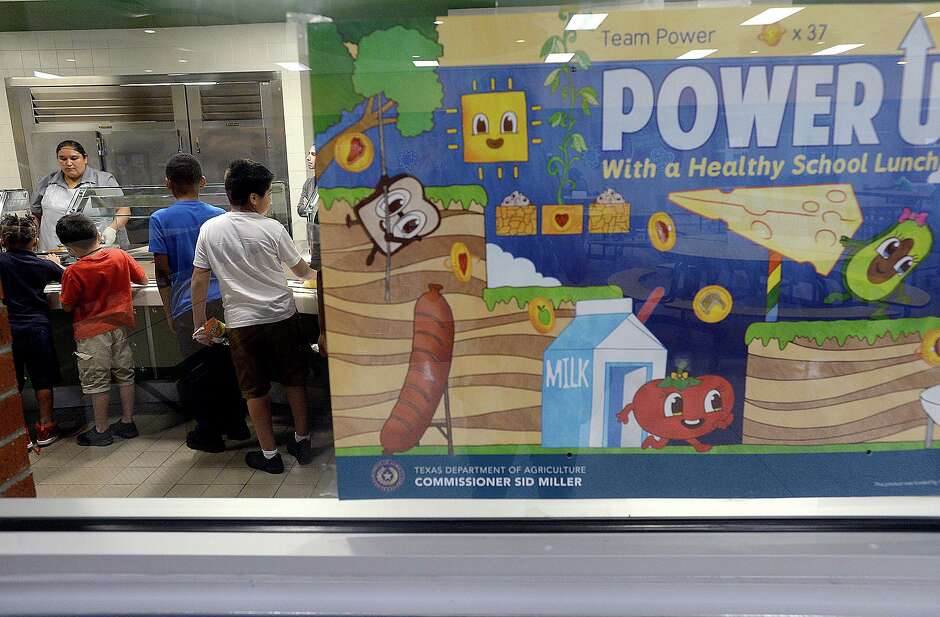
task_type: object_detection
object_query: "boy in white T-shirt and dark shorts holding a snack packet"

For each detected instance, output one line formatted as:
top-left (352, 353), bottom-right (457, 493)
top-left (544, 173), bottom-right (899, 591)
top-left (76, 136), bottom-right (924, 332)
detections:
top-left (192, 159), bottom-right (317, 473)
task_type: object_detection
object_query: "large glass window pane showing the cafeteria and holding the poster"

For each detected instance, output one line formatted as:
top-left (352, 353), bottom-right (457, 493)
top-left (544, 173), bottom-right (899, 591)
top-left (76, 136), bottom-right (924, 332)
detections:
top-left (0, 1), bottom-right (940, 518)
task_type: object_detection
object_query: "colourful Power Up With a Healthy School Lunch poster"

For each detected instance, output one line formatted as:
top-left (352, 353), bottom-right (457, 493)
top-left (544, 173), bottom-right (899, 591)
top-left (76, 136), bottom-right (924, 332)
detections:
top-left (308, 4), bottom-right (940, 499)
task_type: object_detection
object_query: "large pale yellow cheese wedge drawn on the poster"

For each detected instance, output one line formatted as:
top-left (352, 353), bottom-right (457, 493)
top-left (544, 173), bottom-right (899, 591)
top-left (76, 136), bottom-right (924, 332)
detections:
top-left (669, 184), bottom-right (862, 276)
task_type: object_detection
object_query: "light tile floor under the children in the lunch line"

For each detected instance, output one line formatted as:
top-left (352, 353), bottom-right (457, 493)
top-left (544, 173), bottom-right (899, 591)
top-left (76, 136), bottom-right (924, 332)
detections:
top-left (30, 412), bottom-right (336, 498)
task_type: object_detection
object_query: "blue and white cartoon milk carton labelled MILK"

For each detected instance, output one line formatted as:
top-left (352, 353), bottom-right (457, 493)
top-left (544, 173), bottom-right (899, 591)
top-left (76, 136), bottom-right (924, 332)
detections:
top-left (542, 298), bottom-right (666, 448)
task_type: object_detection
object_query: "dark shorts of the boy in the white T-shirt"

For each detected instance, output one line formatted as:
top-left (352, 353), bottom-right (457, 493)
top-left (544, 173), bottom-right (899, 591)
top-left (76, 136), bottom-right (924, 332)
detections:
top-left (226, 313), bottom-right (308, 399)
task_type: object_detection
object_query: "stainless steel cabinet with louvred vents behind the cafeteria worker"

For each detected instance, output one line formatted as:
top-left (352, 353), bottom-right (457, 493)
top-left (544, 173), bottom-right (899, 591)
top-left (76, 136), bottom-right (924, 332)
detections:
top-left (7, 72), bottom-right (287, 201)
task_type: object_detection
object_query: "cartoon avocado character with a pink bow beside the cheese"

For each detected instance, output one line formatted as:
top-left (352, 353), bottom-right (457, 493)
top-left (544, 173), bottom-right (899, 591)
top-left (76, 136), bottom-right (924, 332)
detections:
top-left (826, 208), bottom-right (933, 317)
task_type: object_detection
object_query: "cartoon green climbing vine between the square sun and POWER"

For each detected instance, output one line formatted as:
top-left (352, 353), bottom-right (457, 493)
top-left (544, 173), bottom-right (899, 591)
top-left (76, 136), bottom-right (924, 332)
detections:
top-left (539, 9), bottom-right (598, 204)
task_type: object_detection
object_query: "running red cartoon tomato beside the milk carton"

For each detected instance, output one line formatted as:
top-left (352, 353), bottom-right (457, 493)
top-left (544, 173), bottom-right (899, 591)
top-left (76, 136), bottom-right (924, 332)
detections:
top-left (617, 365), bottom-right (734, 452)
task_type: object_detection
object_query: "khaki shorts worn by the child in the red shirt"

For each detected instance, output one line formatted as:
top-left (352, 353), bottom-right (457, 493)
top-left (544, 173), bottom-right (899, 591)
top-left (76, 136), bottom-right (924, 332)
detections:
top-left (75, 328), bottom-right (134, 394)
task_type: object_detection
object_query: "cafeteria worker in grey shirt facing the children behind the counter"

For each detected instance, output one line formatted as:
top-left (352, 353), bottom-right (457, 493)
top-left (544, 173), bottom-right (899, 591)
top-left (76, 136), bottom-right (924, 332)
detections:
top-left (30, 139), bottom-right (131, 252)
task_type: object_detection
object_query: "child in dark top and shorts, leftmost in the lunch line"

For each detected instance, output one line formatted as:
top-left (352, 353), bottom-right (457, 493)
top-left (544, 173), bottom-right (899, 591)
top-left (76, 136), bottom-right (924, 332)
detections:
top-left (0, 214), bottom-right (63, 446)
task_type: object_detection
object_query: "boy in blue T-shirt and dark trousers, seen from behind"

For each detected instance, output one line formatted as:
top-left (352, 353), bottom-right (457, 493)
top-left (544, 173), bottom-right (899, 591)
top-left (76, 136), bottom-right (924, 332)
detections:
top-left (150, 153), bottom-right (249, 452)
